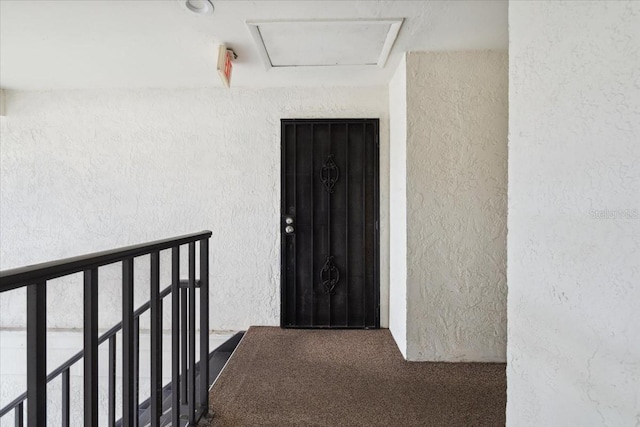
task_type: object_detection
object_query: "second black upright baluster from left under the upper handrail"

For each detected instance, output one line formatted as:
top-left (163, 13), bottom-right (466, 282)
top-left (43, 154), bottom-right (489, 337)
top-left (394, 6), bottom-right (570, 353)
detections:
top-left (84, 268), bottom-right (98, 427)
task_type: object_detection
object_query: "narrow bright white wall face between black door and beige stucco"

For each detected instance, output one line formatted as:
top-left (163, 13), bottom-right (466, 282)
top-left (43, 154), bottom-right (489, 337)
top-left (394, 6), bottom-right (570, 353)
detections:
top-left (389, 58), bottom-right (407, 358)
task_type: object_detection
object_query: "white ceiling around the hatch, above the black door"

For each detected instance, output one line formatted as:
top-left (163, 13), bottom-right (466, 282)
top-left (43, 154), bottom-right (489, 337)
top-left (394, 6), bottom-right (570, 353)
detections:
top-left (0, 0), bottom-right (508, 90)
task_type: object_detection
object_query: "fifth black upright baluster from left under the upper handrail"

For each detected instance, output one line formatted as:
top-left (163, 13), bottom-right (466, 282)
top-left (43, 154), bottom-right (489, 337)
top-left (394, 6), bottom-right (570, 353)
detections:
top-left (171, 246), bottom-right (180, 426)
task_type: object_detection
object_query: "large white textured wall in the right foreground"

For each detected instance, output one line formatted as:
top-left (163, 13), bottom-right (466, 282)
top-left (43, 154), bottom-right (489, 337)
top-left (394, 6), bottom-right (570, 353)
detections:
top-left (507, 1), bottom-right (640, 427)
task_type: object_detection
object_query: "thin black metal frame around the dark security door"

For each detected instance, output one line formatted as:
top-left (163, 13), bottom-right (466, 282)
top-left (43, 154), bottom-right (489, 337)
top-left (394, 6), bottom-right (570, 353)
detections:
top-left (279, 118), bottom-right (380, 329)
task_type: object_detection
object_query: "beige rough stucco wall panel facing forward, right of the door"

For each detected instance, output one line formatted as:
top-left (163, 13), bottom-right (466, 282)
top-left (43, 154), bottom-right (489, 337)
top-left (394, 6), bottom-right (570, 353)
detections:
top-left (406, 51), bottom-right (508, 362)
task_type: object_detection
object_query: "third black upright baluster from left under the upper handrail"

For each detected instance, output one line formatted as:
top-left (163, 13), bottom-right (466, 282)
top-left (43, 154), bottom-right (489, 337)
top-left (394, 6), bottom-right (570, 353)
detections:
top-left (122, 258), bottom-right (137, 427)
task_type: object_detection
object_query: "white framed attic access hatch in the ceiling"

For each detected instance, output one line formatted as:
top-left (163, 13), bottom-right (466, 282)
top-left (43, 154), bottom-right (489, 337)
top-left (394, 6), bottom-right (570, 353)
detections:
top-left (246, 19), bottom-right (403, 69)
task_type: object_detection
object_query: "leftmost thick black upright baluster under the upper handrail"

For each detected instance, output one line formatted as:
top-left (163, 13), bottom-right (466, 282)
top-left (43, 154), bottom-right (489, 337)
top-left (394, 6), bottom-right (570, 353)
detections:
top-left (27, 282), bottom-right (47, 427)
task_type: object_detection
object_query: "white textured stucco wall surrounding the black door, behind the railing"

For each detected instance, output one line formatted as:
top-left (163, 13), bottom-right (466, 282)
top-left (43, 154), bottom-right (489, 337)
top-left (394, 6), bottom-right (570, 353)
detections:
top-left (0, 87), bottom-right (389, 329)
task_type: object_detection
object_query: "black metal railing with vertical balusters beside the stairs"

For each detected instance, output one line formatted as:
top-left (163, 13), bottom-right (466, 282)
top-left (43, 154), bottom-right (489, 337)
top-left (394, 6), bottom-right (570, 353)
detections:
top-left (0, 231), bottom-right (211, 427)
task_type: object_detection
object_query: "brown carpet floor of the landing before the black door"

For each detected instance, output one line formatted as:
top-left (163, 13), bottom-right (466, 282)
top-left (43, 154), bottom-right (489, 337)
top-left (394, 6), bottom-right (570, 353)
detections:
top-left (202, 327), bottom-right (506, 426)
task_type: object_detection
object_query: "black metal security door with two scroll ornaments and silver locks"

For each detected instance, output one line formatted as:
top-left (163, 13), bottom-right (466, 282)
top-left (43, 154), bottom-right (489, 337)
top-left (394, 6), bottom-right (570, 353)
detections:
top-left (280, 119), bottom-right (380, 328)
